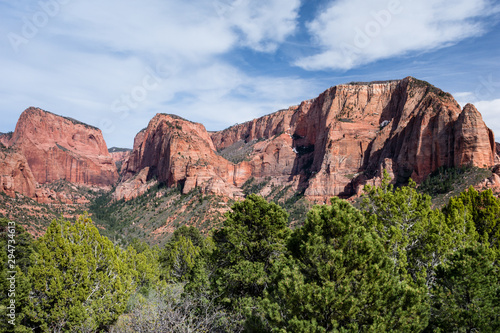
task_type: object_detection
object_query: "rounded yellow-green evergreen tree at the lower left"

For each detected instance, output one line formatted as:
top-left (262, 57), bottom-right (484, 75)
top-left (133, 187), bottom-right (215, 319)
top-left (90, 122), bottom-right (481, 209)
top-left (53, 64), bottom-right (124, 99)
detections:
top-left (28, 216), bottom-right (135, 332)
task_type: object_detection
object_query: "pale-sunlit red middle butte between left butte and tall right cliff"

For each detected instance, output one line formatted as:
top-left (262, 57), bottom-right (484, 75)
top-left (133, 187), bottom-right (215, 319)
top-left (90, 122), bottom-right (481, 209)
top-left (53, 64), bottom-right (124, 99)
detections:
top-left (114, 114), bottom-right (250, 200)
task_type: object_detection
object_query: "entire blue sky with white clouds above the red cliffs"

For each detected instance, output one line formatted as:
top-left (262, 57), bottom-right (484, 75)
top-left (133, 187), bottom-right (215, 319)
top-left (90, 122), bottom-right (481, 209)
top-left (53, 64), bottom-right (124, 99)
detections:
top-left (0, 0), bottom-right (500, 147)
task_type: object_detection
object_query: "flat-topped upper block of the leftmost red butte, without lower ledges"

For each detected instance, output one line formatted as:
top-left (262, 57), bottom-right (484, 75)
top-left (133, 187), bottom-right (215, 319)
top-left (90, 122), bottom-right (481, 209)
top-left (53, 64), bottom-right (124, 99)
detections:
top-left (9, 107), bottom-right (118, 186)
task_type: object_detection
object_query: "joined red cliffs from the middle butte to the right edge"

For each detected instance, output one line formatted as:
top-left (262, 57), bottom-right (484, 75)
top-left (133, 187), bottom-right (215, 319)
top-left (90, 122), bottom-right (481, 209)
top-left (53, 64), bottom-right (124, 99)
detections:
top-left (115, 77), bottom-right (495, 201)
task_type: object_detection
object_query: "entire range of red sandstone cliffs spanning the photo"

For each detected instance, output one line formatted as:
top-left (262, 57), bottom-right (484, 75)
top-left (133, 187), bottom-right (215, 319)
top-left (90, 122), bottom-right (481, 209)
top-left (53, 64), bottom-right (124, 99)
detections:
top-left (0, 77), bottom-right (500, 202)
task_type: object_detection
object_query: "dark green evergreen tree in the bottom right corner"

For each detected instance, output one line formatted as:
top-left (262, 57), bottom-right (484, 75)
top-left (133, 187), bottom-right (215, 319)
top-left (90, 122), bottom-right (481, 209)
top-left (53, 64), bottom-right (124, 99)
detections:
top-left (430, 243), bottom-right (500, 332)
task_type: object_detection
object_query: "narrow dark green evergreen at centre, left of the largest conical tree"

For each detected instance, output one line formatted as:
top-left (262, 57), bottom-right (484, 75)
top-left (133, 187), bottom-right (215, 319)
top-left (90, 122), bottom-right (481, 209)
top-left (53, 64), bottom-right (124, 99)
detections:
top-left (212, 194), bottom-right (291, 305)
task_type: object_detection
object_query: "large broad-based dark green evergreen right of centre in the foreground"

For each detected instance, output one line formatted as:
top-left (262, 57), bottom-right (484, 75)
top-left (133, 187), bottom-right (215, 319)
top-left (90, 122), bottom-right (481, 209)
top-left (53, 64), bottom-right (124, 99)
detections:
top-left (262, 198), bottom-right (427, 332)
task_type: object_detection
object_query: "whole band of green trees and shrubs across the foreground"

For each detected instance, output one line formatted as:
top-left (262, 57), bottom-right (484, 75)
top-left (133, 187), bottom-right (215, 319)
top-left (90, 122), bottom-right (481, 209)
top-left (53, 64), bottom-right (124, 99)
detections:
top-left (0, 170), bottom-right (500, 333)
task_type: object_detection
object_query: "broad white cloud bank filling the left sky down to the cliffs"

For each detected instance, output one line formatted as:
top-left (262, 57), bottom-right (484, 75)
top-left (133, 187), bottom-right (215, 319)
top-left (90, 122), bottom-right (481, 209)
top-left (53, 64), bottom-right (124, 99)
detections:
top-left (0, 0), bottom-right (300, 146)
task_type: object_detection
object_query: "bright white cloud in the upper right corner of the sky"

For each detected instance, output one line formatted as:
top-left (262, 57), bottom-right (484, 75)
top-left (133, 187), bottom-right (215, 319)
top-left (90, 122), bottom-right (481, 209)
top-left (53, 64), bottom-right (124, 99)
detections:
top-left (295, 0), bottom-right (500, 70)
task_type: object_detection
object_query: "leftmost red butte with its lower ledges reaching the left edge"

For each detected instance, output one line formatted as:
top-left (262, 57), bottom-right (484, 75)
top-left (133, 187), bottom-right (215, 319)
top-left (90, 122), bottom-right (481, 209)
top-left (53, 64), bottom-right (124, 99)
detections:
top-left (0, 107), bottom-right (118, 203)
